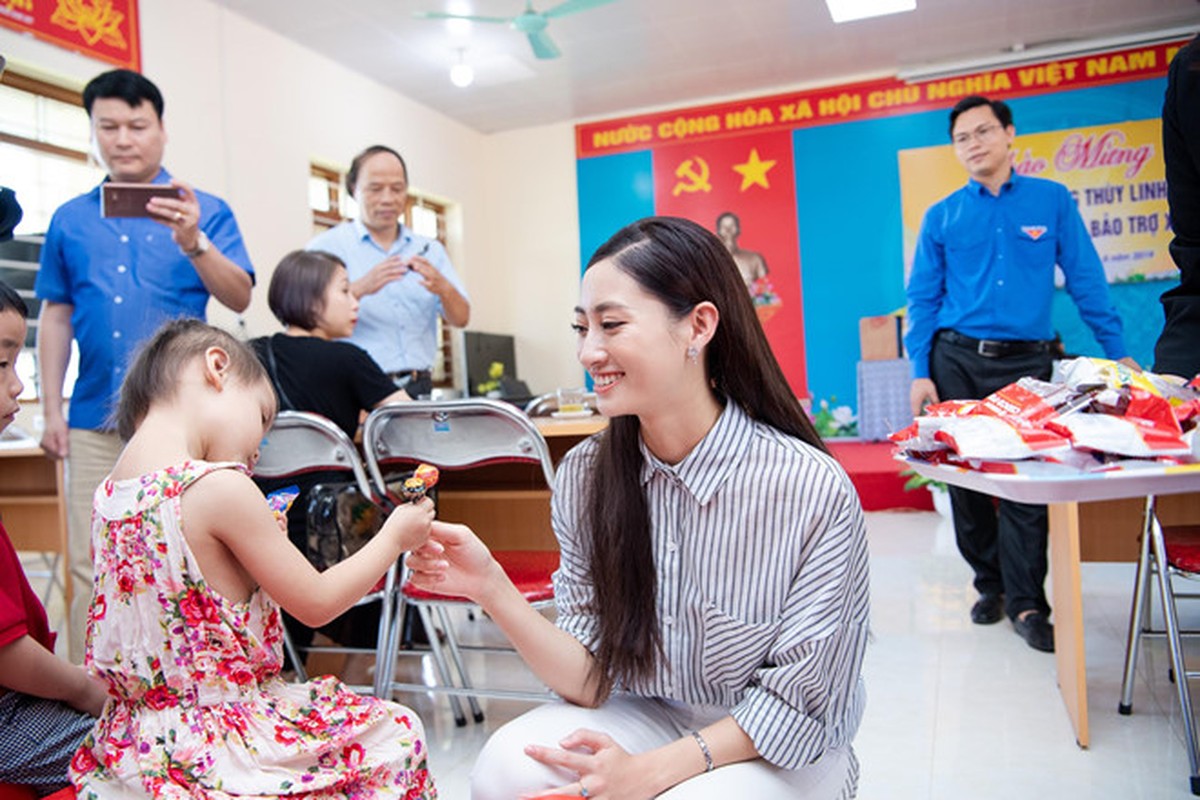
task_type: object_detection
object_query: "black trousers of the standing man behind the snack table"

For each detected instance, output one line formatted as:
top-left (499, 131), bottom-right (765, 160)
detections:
top-left (929, 337), bottom-right (1052, 619)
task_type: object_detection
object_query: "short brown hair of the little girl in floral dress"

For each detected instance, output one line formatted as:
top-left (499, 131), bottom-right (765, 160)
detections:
top-left (115, 319), bottom-right (268, 441)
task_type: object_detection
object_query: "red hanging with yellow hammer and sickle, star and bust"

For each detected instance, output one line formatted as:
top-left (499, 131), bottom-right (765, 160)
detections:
top-left (654, 131), bottom-right (809, 397)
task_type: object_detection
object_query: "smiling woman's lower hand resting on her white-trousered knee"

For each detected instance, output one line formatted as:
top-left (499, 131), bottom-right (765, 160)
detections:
top-left (522, 728), bottom-right (659, 800)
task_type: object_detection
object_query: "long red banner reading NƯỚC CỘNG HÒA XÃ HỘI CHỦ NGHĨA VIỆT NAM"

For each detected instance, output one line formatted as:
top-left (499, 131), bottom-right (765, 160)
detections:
top-left (578, 40), bottom-right (1187, 158)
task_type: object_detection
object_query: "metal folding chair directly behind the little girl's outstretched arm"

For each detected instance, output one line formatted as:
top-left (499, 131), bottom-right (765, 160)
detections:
top-left (254, 411), bottom-right (400, 697)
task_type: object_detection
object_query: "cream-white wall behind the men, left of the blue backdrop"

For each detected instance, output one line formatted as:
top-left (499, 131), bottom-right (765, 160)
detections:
top-left (0, 0), bottom-right (582, 391)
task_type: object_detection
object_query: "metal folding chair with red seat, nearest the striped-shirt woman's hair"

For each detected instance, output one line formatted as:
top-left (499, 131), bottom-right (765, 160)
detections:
top-left (362, 398), bottom-right (558, 724)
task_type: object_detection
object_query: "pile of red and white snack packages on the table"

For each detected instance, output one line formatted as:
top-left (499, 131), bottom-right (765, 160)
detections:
top-left (889, 359), bottom-right (1200, 477)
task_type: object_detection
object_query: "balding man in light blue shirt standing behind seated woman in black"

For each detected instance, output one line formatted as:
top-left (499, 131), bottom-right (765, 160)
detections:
top-left (308, 145), bottom-right (470, 398)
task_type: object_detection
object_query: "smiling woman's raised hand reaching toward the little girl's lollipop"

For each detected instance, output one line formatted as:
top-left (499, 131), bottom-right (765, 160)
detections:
top-left (406, 521), bottom-right (504, 602)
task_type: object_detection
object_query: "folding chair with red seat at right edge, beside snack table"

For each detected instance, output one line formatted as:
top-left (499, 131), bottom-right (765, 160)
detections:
top-left (1117, 495), bottom-right (1200, 795)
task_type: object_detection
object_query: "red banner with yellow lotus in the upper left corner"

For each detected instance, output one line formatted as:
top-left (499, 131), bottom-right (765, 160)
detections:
top-left (0, 0), bottom-right (142, 72)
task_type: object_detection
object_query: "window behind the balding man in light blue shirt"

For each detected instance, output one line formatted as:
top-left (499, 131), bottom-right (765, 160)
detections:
top-left (308, 164), bottom-right (454, 387)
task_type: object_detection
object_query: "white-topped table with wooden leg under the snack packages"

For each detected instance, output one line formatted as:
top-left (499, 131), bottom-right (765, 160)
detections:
top-left (905, 459), bottom-right (1200, 747)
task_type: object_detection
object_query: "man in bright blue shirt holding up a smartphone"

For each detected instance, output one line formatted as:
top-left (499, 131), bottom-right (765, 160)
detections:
top-left (35, 70), bottom-right (254, 662)
